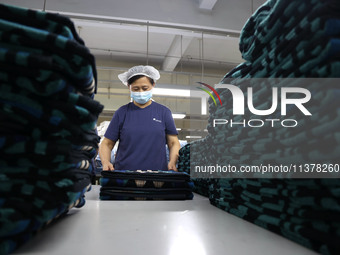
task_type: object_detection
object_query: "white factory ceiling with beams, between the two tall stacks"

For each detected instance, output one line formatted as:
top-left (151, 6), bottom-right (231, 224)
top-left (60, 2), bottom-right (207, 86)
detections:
top-left (0, 0), bottom-right (264, 71)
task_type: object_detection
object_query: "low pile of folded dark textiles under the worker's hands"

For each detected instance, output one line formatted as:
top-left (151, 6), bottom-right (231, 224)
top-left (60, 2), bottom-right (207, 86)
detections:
top-left (100, 170), bottom-right (193, 200)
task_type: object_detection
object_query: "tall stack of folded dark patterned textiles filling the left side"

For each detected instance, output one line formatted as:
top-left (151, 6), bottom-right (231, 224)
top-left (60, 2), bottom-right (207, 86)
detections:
top-left (0, 4), bottom-right (103, 254)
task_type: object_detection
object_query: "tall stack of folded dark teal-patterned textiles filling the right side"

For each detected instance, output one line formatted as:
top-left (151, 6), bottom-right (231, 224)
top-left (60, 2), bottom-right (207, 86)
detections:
top-left (180, 0), bottom-right (340, 254)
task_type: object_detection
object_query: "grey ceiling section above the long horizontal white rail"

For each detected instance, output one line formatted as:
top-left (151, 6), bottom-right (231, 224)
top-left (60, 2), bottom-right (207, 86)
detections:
top-left (44, 0), bottom-right (252, 31)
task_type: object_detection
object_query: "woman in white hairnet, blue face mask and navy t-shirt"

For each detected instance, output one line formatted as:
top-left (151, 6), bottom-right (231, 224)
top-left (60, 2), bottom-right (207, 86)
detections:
top-left (99, 65), bottom-right (180, 171)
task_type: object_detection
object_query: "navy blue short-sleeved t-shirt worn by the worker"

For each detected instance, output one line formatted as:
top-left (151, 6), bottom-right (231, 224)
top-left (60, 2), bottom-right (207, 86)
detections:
top-left (104, 101), bottom-right (178, 170)
